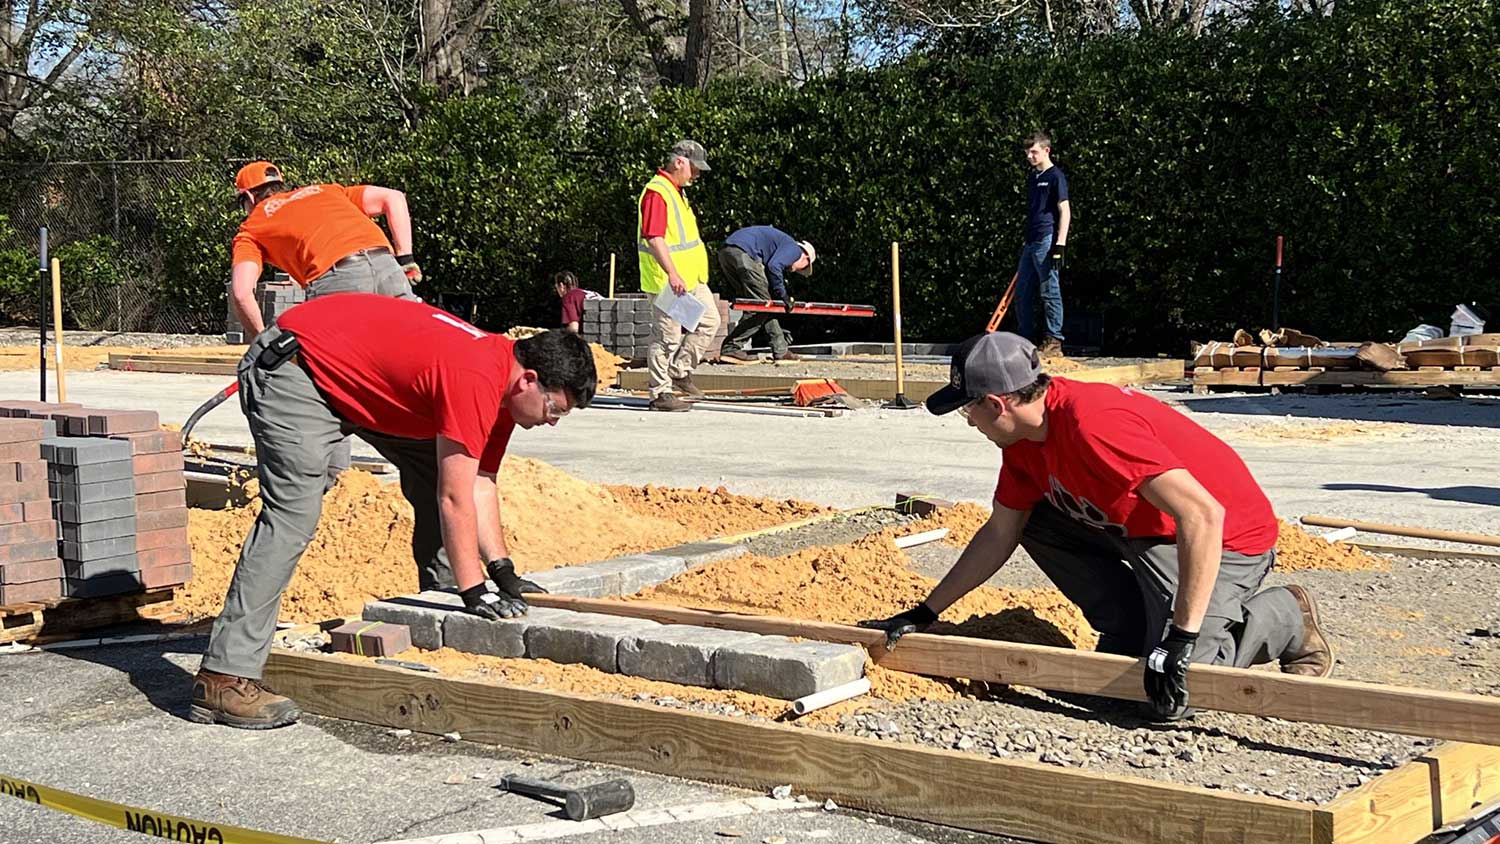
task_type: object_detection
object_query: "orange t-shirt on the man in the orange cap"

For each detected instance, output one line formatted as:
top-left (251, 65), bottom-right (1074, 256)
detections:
top-left (233, 184), bottom-right (390, 286)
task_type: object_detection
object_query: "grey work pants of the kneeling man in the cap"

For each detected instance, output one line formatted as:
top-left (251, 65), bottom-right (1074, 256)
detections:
top-left (1022, 502), bottom-right (1302, 669)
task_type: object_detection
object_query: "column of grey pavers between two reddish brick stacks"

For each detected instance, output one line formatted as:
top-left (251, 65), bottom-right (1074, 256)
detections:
top-left (42, 434), bottom-right (141, 598)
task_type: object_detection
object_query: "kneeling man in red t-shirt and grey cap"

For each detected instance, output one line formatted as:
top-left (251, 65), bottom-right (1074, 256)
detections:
top-left (861, 333), bottom-right (1334, 720)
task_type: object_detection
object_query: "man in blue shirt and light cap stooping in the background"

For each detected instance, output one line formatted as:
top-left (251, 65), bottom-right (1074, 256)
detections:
top-left (719, 226), bottom-right (818, 363)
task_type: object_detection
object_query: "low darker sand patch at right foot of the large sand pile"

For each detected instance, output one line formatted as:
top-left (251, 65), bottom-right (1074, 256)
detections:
top-left (605, 484), bottom-right (833, 537)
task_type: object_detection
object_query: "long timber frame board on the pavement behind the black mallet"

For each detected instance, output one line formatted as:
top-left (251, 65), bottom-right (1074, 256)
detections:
top-left (266, 649), bottom-right (1325, 844)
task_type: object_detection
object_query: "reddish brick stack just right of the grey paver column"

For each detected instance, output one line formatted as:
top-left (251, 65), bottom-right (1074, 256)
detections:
top-left (111, 430), bottom-right (192, 589)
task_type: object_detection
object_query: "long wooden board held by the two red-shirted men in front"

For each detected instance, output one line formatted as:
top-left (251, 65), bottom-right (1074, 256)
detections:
top-left (527, 595), bottom-right (1500, 744)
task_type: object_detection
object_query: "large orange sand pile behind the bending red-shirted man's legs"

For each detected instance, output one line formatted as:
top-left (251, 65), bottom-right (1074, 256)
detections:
top-left (174, 457), bottom-right (812, 622)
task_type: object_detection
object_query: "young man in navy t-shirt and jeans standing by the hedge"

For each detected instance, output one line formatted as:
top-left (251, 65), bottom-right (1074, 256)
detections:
top-left (1016, 132), bottom-right (1073, 357)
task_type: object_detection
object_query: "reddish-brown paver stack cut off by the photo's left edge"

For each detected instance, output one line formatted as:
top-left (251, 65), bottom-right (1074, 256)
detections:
top-left (0, 417), bottom-right (63, 606)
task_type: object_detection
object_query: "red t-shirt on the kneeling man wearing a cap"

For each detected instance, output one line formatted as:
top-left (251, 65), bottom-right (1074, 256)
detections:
top-left (995, 378), bottom-right (1278, 556)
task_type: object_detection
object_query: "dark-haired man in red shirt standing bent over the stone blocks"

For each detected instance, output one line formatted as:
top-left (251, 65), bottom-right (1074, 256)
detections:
top-left (191, 294), bottom-right (596, 729)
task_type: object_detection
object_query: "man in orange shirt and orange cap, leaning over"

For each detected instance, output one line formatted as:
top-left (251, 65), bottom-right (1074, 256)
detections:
top-left (230, 162), bottom-right (422, 486)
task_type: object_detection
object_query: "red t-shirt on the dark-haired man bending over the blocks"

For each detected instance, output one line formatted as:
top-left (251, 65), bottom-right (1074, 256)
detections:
top-left (276, 294), bottom-right (516, 472)
